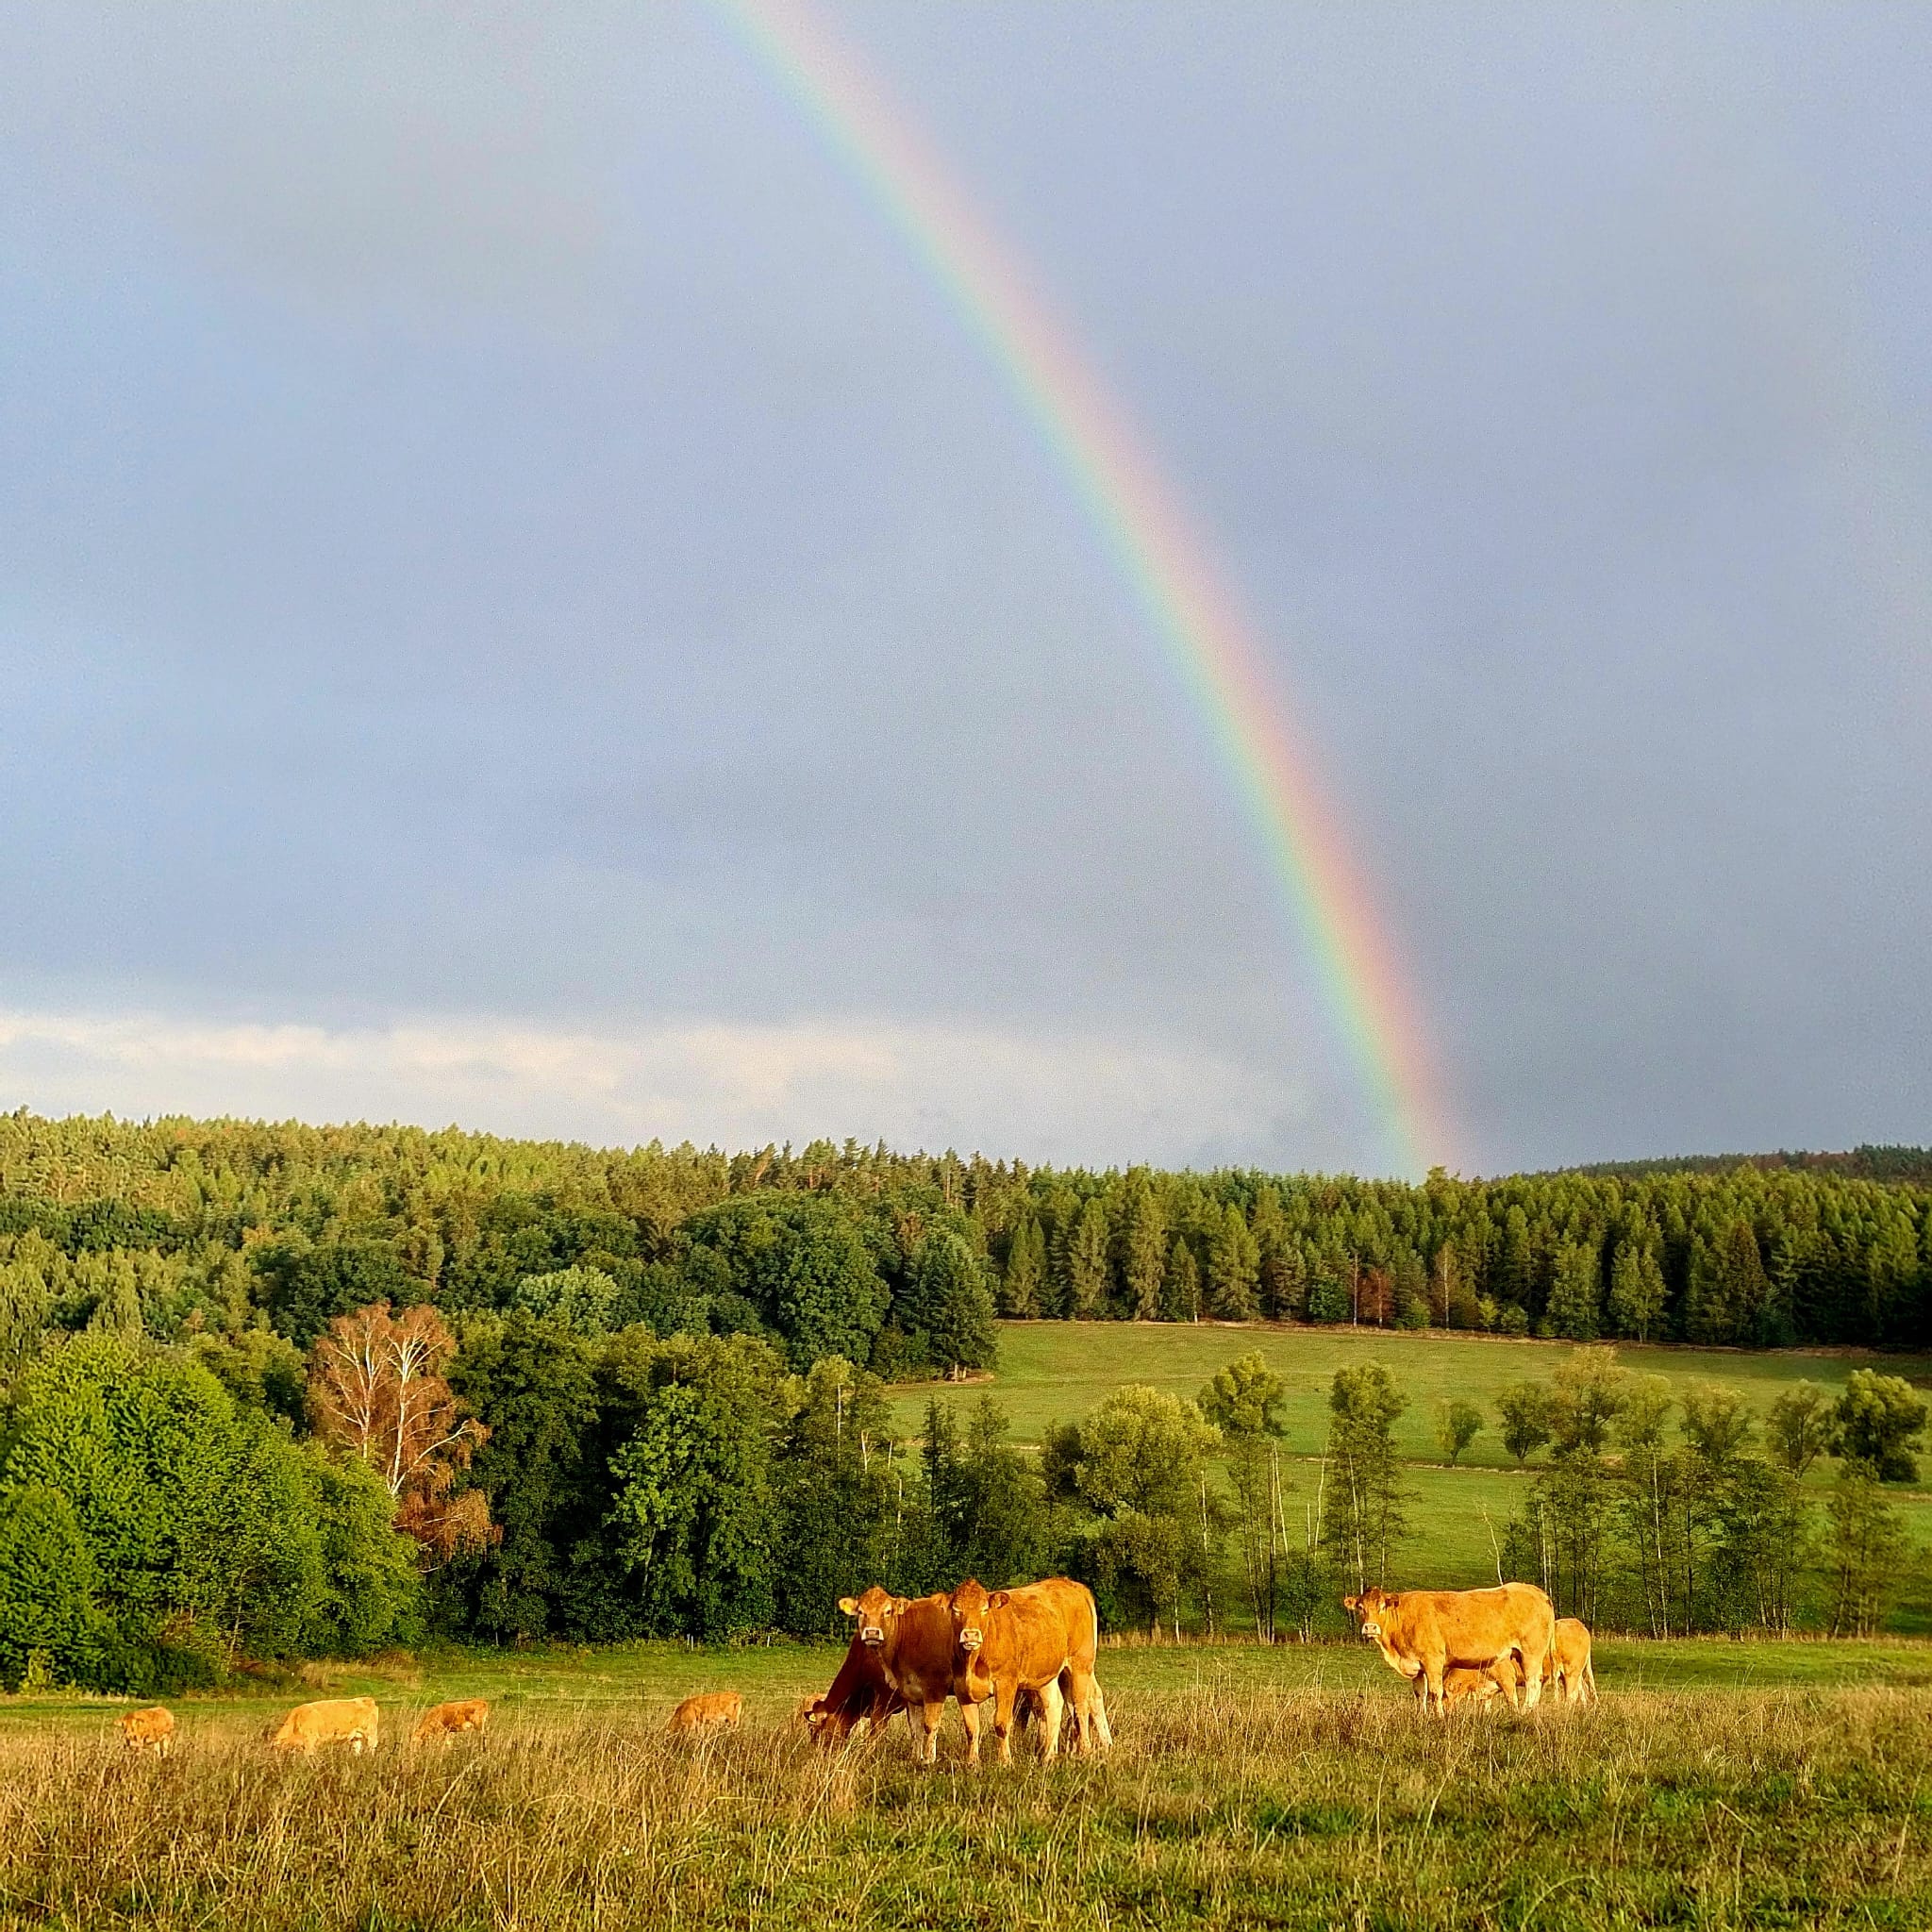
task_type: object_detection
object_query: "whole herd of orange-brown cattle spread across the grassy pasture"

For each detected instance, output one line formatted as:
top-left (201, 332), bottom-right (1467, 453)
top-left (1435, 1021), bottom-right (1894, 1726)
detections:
top-left (118, 1576), bottom-right (1596, 1764)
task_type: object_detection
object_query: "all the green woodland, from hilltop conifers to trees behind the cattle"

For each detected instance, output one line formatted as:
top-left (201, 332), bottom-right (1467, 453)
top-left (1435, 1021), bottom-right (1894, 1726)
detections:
top-left (0, 1111), bottom-right (1932, 1690)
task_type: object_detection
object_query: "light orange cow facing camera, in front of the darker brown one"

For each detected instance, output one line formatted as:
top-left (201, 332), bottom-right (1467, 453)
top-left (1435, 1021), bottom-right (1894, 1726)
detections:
top-left (947, 1576), bottom-right (1113, 1764)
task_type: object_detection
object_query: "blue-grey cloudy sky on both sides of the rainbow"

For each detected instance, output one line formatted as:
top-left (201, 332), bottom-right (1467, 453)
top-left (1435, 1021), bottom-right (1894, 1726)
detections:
top-left (0, 4), bottom-right (1932, 1171)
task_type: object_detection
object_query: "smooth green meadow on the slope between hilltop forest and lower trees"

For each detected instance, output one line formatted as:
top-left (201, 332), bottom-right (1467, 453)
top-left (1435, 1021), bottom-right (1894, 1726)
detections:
top-left (894, 1322), bottom-right (1932, 1635)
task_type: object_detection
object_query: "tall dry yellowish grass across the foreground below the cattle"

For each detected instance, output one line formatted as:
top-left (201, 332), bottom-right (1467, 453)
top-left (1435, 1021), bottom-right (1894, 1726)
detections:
top-left (0, 1687), bottom-right (1932, 1932)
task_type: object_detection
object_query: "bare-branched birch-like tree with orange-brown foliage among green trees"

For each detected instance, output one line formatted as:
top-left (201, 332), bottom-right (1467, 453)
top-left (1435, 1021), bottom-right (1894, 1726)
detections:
top-left (309, 1302), bottom-right (502, 1559)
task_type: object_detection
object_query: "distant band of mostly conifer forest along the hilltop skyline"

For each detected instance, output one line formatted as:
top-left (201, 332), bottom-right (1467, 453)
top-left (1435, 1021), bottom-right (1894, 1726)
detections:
top-left (0, 1113), bottom-right (1932, 1379)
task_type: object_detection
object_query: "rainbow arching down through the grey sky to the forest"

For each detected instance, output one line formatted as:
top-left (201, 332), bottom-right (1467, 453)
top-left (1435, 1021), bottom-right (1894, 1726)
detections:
top-left (711, 0), bottom-right (1447, 1174)
